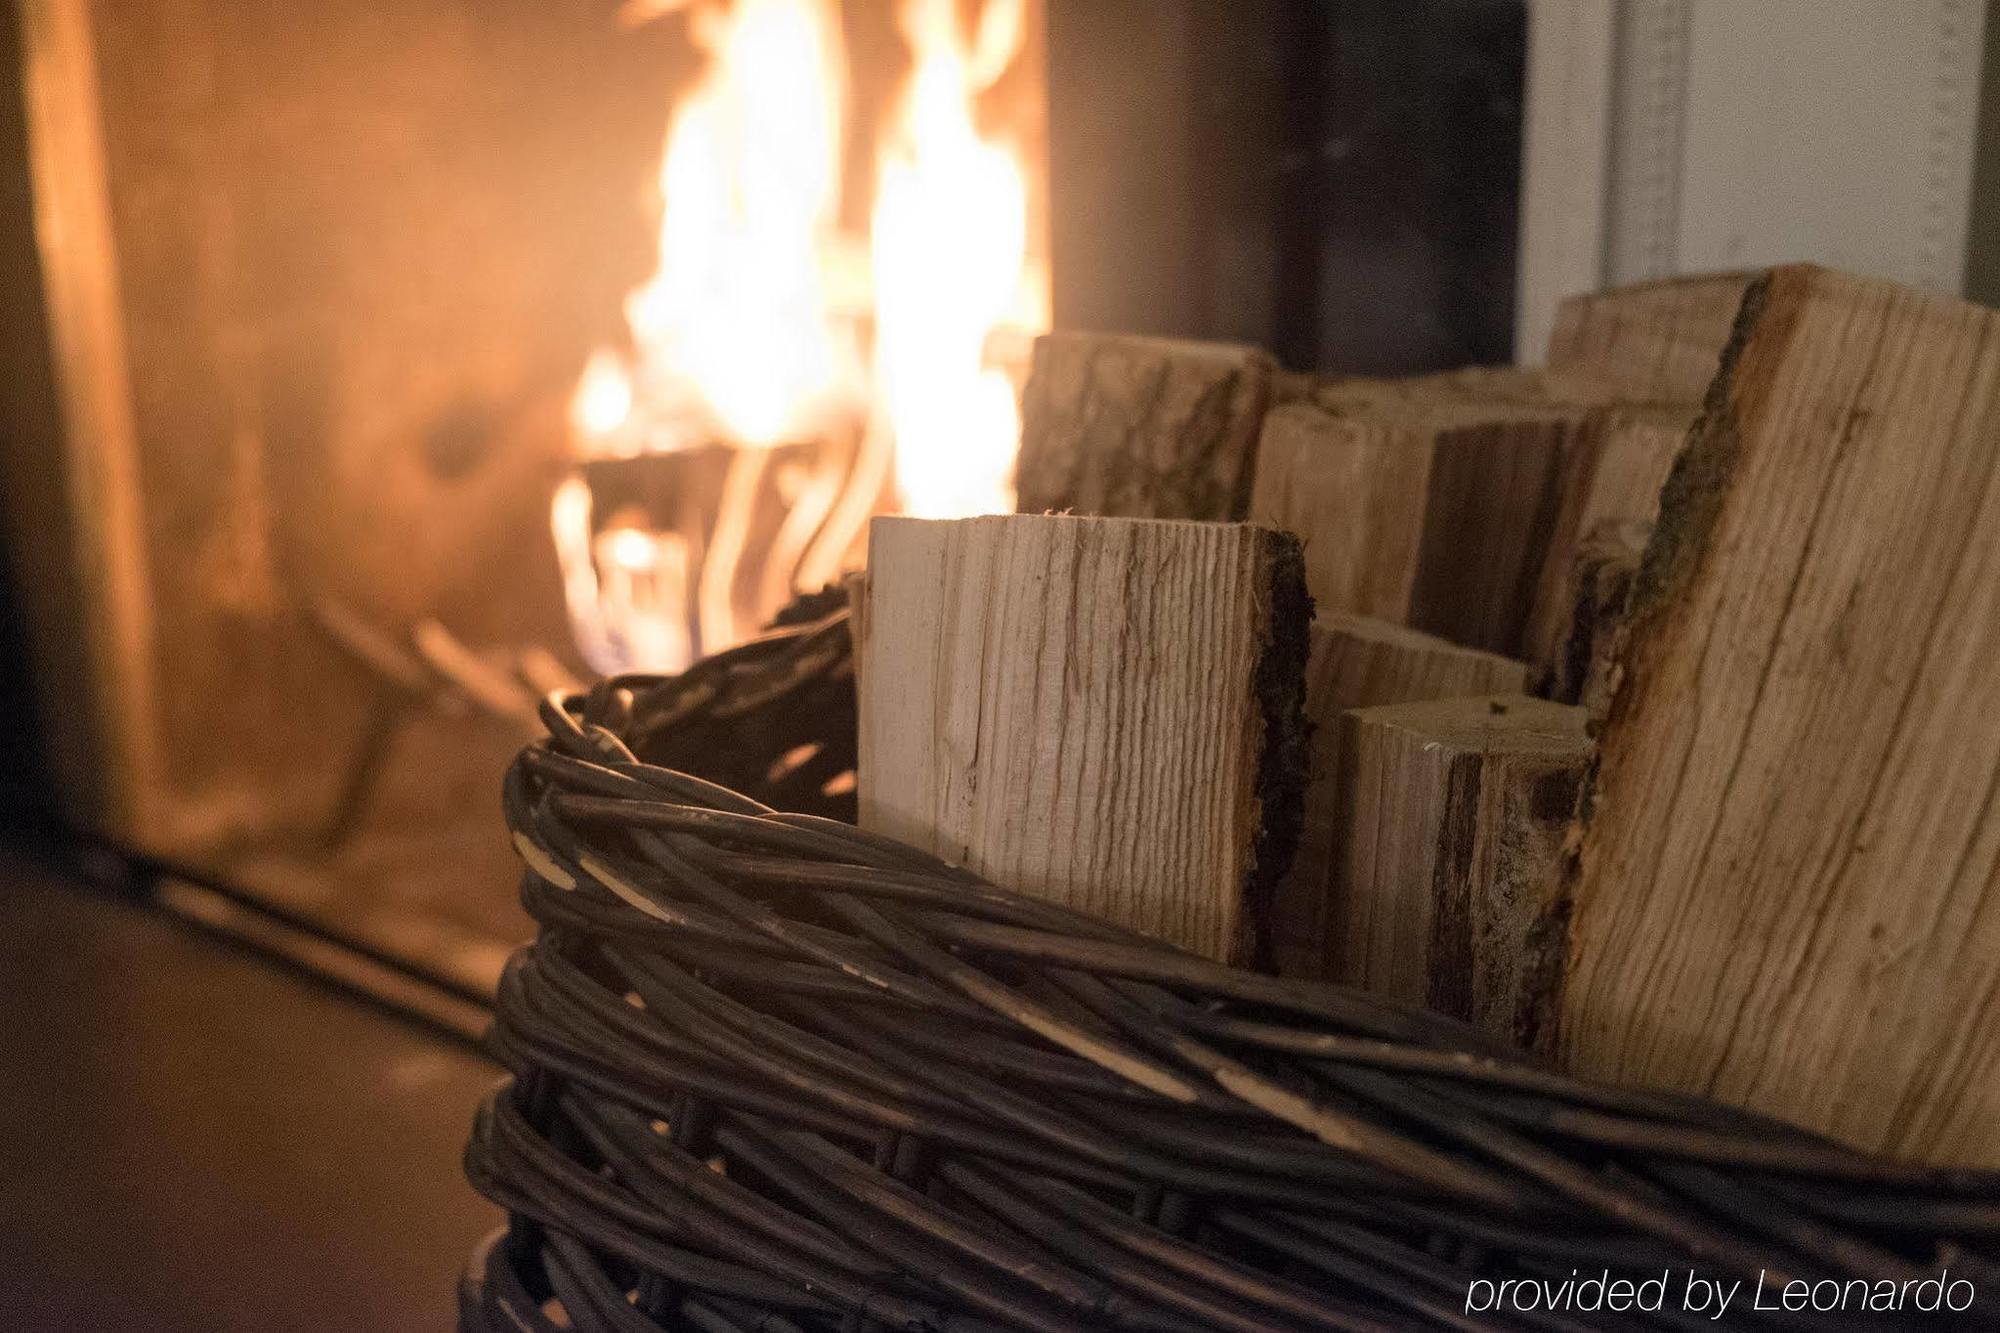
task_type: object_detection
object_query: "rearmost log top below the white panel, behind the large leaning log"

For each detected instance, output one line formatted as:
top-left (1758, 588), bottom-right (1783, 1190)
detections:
top-left (1548, 272), bottom-right (1754, 402)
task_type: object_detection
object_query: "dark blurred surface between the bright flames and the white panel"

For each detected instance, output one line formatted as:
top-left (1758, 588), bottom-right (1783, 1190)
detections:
top-left (1048, 0), bottom-right (1528, 374)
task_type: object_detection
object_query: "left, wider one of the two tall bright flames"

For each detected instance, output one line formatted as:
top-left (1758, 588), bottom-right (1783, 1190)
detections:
top-left (572, 0), bottom-right (858, 452)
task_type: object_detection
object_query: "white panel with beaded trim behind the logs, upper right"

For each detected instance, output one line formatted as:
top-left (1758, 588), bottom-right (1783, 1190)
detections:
top-left (1516, 0), bottom-right (1986, 360)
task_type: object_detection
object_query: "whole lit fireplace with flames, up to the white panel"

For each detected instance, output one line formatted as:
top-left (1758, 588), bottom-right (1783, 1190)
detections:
top-left (4, 0), bottom-right (1526, 987)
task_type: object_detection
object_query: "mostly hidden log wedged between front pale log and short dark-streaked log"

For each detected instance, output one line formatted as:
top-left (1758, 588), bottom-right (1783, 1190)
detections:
top-left (1272, 612), bottom-right (1528, 977)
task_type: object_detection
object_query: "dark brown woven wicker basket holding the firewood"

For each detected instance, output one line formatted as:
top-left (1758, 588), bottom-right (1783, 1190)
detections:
top-left (462, 614), bottom-right (2000, 1331)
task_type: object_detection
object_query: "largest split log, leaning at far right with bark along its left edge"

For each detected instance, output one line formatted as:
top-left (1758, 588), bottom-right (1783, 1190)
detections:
top-left (1562, 266), bottom-right (2000, 1165)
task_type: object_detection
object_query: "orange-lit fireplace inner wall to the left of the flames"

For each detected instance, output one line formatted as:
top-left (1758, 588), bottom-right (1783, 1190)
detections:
top-left (8, 0), bottom-right (694, 971)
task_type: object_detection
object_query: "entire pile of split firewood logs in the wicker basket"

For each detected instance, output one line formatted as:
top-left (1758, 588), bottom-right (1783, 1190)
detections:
top-left (858, 266), bottom-right (2000, 1165)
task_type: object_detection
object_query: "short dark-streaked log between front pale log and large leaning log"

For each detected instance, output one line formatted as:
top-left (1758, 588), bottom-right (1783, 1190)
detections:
top-left (1328, 695), bottom-right (1592, 1049)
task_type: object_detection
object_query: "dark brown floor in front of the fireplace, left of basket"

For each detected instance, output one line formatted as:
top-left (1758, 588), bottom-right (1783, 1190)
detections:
top-left (0, 851), bottom-right (498, 1331)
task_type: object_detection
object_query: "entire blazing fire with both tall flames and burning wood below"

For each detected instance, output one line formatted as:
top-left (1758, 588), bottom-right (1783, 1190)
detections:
top-left (552, 0), bottom-right (1046, 673)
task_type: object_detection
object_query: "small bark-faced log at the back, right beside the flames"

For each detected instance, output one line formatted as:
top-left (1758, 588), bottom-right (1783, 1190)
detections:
top-left (1016, 332), bottom-right (1276, 518)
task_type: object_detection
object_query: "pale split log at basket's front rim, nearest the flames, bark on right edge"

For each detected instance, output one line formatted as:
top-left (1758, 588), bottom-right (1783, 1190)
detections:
top-left (858, 514), bottom-right (1312, 961)
